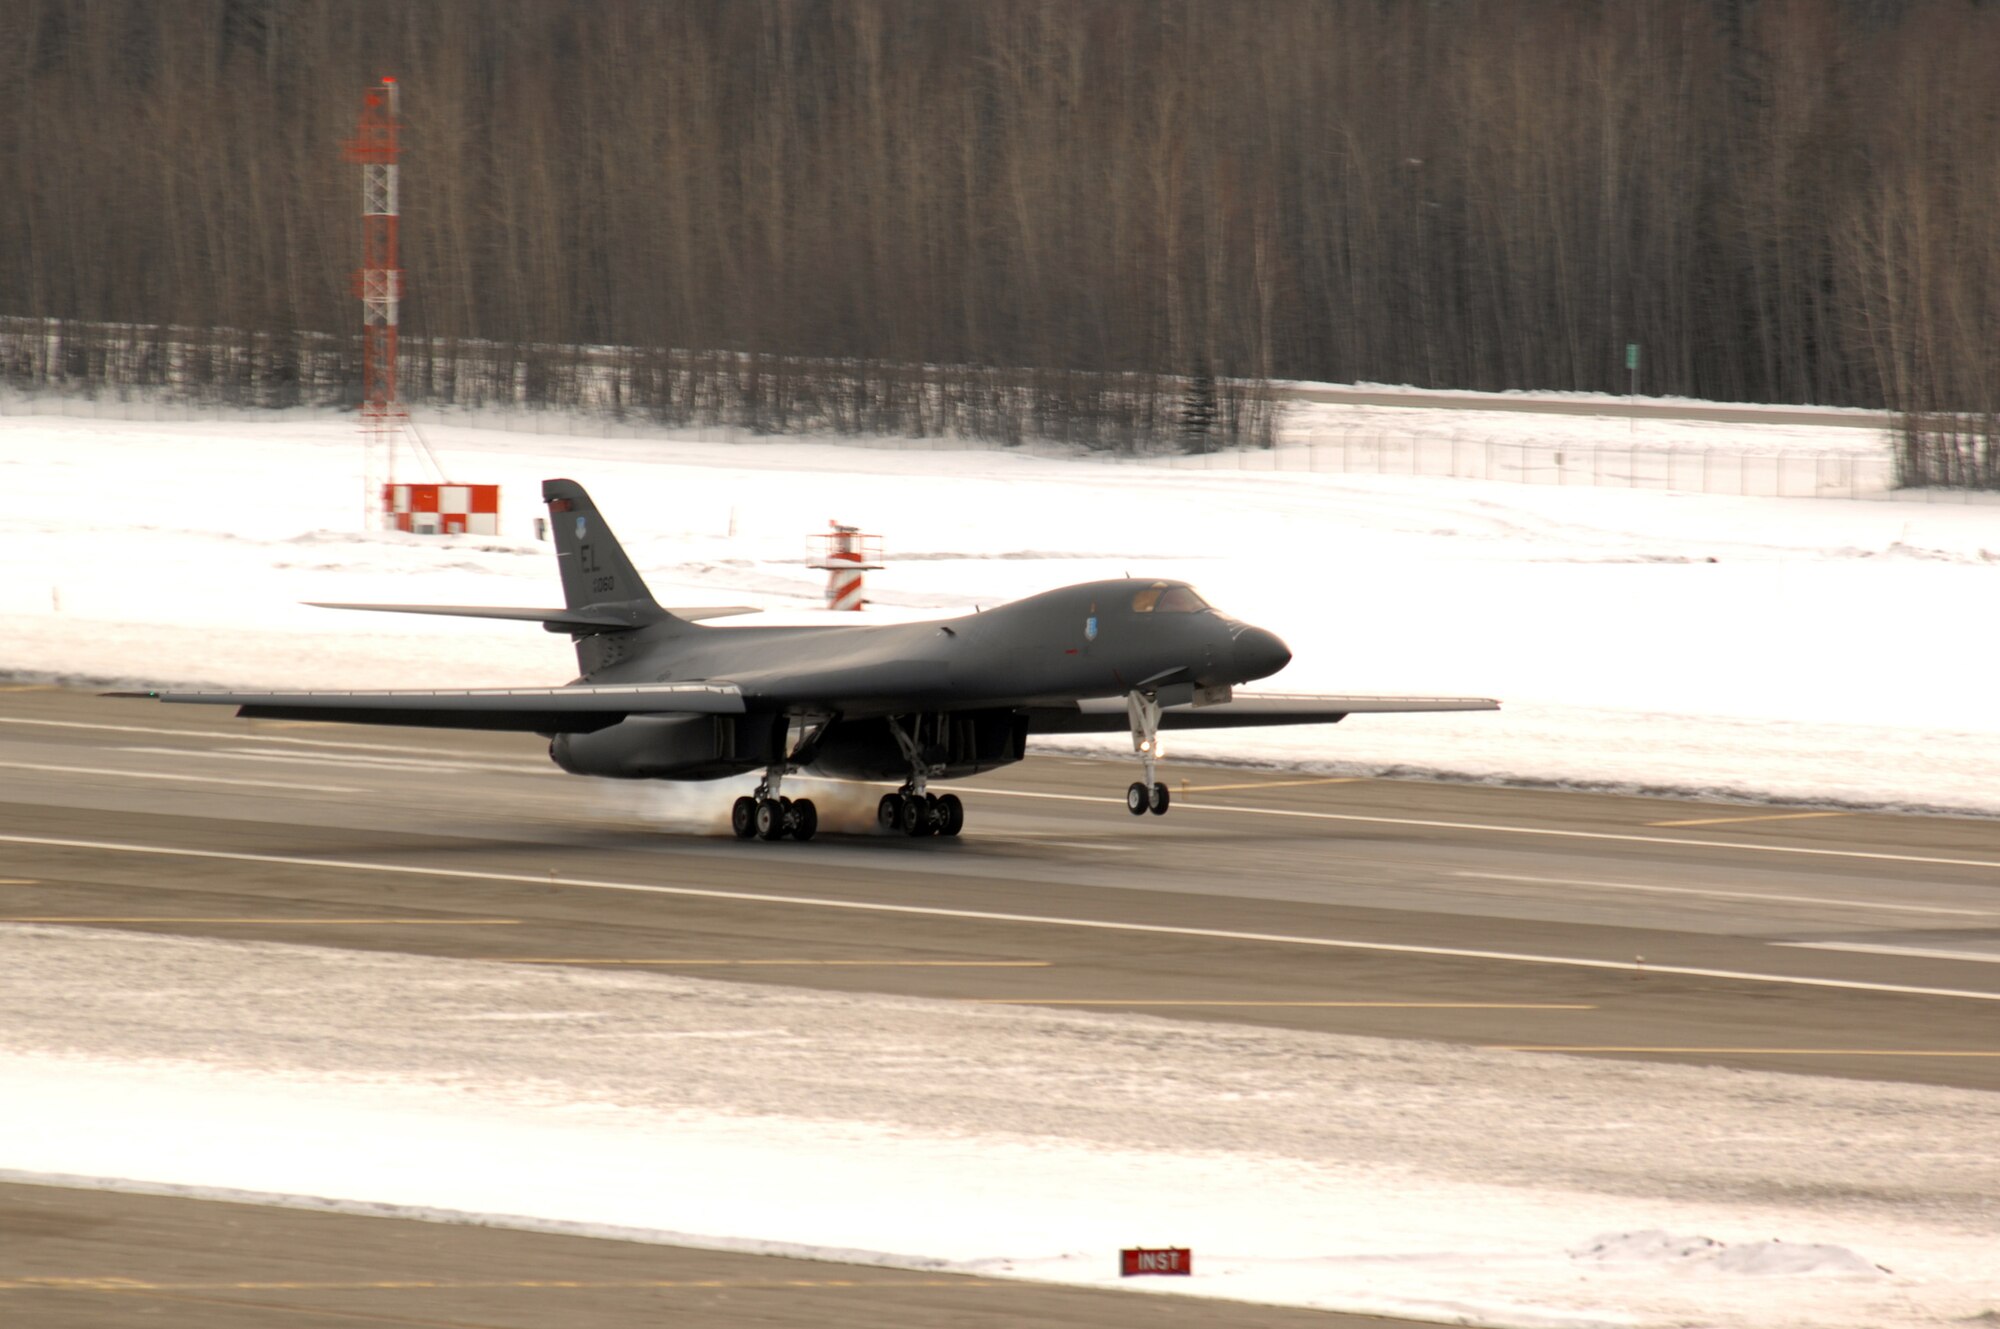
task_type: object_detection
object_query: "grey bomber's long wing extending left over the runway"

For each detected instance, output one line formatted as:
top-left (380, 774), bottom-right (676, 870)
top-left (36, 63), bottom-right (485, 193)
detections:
top-left (123, 683), bottom-right (744, 735)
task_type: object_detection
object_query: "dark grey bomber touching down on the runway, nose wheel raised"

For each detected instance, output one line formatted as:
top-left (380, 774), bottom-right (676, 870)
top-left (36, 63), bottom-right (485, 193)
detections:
top-left (125, 480), bottom-right (1500, 841)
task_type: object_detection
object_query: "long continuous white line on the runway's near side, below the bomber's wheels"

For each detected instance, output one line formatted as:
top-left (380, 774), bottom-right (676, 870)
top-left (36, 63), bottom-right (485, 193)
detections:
top-left (11, 835), bottom-right (2000, 1001)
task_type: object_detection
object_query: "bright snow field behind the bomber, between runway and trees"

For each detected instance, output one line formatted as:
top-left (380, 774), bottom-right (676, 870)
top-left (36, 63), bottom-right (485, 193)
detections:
top-left (0, 412), bottom-right (2000, 813)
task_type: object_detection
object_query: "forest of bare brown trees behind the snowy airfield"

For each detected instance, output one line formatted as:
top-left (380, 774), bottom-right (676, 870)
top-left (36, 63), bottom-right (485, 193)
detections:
top-left (0, 0), bottom-right (2000, 482)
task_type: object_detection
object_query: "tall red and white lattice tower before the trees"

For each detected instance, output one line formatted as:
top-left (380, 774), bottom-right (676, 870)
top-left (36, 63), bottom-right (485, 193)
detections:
top-left (346, 78), bottom-right (408, 524)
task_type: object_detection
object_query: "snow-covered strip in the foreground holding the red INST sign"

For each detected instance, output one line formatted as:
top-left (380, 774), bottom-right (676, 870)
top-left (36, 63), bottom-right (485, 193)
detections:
top-left (11, 927), bottom-right (2000, 1329)
